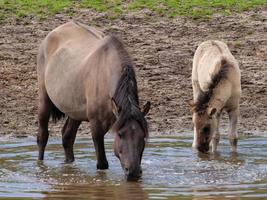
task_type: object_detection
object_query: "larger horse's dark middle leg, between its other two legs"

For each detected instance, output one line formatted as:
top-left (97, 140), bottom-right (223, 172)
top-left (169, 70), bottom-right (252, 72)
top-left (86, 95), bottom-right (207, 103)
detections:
top-left (61, 117), bottom-right (81, 162)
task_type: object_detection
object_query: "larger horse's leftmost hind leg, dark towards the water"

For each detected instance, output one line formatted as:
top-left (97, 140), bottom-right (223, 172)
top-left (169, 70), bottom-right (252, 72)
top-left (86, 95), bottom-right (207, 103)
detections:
top-left (37, 91), bottom-right (52, 160)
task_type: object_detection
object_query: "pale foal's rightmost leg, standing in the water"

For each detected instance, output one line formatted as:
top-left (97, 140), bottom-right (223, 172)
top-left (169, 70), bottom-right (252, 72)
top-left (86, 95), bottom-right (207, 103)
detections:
top-left (228, 108), bottom-right (239, 152)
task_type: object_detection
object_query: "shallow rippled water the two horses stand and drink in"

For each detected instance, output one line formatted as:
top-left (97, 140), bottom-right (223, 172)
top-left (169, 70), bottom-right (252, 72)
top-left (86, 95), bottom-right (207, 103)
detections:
top-left (0, 136), bottom-right (267, 199)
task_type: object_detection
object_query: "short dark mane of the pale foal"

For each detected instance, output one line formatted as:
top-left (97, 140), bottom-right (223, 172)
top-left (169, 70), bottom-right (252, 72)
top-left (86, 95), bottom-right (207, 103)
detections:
top-left (195, 59), bottom-right (229, 114)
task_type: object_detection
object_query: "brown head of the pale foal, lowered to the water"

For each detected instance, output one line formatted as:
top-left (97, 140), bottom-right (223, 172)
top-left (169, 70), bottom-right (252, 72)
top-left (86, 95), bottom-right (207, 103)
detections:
top-left (189, 102), bottom-right (217, 153)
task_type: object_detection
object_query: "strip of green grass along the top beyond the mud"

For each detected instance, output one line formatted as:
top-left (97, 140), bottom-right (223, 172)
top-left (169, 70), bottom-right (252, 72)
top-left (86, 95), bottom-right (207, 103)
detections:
top-left (0, 0), bottom-right (267, 20)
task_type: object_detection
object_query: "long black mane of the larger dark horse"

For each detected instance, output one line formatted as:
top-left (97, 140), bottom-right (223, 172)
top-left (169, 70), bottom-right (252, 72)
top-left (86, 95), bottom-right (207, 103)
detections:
top-left (110, 36), bottom-right (148, 137)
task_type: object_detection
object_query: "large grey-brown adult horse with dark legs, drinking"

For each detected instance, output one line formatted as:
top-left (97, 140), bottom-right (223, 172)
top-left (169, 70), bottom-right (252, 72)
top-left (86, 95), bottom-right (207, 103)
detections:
top-left (37, 22), bottom-right (150, 179)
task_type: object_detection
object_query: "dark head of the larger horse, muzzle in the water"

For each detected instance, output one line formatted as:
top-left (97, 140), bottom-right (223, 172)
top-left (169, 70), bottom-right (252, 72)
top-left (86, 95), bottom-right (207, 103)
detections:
top-left (111, 99), bottom-right (150, 180)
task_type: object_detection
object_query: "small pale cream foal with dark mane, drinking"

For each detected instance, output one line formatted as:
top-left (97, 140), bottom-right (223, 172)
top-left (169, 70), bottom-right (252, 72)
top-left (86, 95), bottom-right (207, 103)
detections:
top-left (189, 41), bottom-right (241, 152)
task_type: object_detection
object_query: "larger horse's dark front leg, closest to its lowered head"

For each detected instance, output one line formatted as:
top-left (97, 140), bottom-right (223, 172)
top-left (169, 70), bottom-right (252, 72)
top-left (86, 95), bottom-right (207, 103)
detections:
top-left (91, 121), bottom-right (110, 169)
